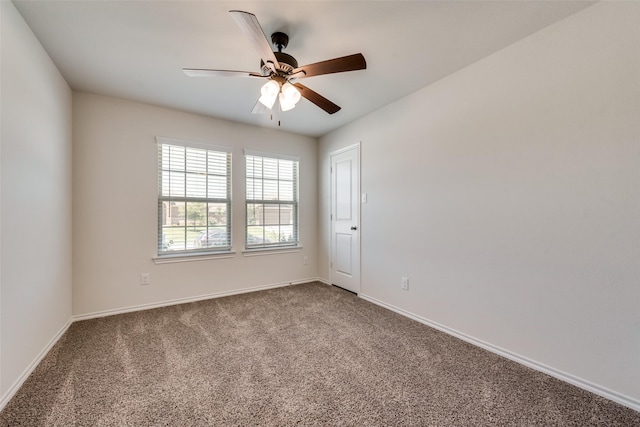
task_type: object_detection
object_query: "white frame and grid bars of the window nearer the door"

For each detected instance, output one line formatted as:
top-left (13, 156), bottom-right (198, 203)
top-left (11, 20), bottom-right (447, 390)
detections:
top-left (244, 150), bottom-right (301, 253)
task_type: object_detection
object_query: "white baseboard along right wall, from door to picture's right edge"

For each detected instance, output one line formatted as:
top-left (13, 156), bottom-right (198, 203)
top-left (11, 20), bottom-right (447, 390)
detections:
top-left (358, 294), bottom-right (640, 412)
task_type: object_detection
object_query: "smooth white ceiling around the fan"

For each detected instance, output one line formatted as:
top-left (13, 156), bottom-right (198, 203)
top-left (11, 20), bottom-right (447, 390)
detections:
top-left (13, 0), bottom-right (591, 136)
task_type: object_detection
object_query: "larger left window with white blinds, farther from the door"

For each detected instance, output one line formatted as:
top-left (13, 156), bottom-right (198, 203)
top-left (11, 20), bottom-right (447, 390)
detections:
top-left (157, 138), bottom-right (231, 255)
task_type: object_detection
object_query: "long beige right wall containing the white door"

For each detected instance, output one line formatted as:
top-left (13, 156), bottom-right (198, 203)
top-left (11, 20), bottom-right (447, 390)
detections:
top-left (319, 2), bottom-right (640, 408)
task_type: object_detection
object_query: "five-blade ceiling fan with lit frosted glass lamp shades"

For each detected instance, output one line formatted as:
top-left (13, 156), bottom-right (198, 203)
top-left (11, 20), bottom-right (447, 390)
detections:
top-left (182, 10), bottom-right (367, 114)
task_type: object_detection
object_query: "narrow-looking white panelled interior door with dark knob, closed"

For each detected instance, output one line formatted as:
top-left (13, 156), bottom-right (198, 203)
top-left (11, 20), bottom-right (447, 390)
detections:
top-left (331, 145), bottom-right (360, 293)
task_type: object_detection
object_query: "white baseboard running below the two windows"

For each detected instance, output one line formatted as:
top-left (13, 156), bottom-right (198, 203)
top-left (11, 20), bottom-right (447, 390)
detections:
top-left (72, 277), bottom-right (319, 322)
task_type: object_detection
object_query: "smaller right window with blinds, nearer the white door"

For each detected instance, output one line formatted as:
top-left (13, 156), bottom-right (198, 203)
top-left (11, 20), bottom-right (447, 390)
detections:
top-left (245, 152), bottom-right (299, 249)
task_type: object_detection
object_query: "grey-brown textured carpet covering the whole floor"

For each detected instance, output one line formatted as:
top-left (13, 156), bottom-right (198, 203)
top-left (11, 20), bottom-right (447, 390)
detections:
top-left (0, 283), bottom-right (640, 426)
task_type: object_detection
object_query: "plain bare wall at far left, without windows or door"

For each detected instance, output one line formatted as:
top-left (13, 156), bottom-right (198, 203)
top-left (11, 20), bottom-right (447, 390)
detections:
top-left (0, 1), bottom-right (72, 402)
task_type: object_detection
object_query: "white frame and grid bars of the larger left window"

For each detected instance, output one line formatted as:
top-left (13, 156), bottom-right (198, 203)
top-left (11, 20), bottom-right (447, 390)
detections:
top-left (156, 137), bottom-right (233, 260)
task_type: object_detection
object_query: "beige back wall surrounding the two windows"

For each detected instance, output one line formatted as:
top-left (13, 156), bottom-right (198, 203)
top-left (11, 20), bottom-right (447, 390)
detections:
top-left (73, 93), bottom-right (318, 315)
